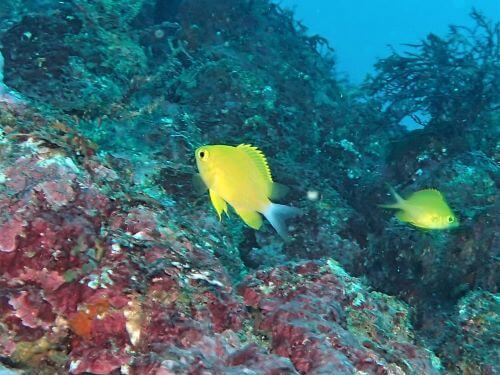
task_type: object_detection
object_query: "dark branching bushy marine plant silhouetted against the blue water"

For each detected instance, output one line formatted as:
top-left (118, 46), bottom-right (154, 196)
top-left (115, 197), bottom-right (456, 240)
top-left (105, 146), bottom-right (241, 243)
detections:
top-left (366, 10), bottom-right (500, 160)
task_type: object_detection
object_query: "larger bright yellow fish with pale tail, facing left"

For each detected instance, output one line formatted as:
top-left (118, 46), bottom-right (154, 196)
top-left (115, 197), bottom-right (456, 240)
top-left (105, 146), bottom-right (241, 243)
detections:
top-left (195, 144), bottom-right (300, 238)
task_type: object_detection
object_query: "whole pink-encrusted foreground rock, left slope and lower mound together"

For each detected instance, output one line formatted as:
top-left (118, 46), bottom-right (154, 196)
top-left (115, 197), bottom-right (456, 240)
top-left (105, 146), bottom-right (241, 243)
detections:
top-left (0, 117), bottom-right (438, 375)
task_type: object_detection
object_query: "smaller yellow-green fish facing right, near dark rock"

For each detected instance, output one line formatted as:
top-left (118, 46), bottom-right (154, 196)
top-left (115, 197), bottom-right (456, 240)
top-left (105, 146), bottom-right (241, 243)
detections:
top-left (380, 188), bottom-right (458, 229)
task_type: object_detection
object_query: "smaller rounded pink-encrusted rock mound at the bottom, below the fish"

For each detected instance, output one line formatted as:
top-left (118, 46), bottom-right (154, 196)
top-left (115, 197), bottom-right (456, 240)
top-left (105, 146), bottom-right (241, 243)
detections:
top-left (240, 261), bottom-right (439, 374)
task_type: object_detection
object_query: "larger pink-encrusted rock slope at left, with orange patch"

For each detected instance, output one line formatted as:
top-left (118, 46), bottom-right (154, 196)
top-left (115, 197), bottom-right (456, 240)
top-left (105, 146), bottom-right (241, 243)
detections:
top-left (0, 129), bottom-right (295, 374)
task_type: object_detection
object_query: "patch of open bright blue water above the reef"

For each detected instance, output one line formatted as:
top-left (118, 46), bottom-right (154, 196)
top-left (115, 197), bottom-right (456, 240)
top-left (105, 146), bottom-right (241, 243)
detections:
top-left (276, 0), bottom-right (500, 83)
